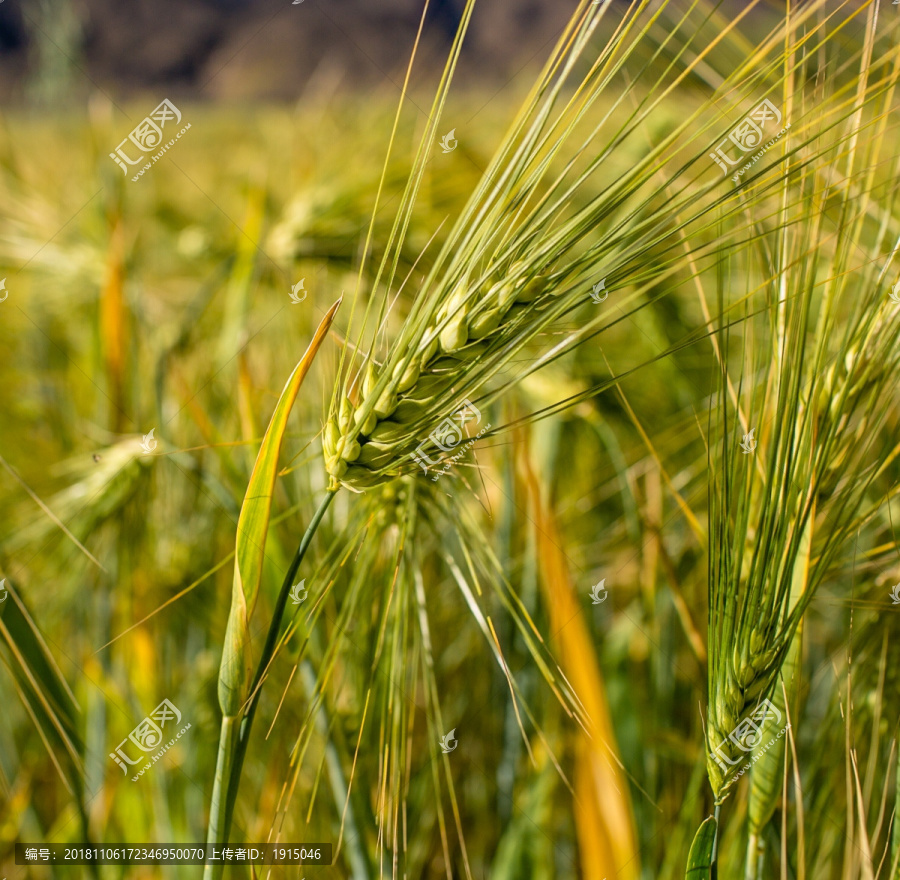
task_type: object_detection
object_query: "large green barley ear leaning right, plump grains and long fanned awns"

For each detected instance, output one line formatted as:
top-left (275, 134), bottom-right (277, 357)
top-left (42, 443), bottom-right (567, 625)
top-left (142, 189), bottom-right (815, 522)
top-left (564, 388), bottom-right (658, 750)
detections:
top-left (324, 0), bottom-right (844, 490)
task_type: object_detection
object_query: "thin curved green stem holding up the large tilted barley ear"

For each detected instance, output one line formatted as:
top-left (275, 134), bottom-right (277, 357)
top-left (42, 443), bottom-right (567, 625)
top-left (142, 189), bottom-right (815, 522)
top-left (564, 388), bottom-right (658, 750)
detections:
top-left (203, 487), bottom-right (337, 880)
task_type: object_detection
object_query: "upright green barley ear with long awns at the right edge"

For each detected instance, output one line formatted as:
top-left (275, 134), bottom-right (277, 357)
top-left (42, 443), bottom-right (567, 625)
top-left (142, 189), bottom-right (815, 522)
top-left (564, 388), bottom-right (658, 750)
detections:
top-left (706, 0), bottom-right (900, 824)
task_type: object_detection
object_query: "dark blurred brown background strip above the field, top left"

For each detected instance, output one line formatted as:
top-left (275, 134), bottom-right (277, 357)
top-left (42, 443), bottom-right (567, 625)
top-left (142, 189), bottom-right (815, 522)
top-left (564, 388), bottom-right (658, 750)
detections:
top-left (0, 0), bottom-right (577, 107)
